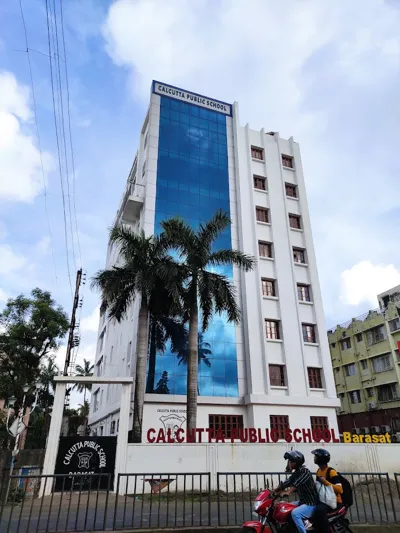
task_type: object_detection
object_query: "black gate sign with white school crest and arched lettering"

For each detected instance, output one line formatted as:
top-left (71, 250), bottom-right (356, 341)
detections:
top-left (55, 435), bottom-right (117, 490)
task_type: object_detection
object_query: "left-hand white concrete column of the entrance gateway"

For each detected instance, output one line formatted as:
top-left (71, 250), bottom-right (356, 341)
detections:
top-left (39, 382), bottom-right (67, 497)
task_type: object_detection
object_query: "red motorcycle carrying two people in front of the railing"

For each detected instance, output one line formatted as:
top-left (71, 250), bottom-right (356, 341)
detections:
top-left (242, 489), bottom-right (351, 533)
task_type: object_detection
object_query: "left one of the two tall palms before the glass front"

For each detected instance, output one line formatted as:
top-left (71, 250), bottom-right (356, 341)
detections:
top-left (92, 225), bottom-right (179, 442)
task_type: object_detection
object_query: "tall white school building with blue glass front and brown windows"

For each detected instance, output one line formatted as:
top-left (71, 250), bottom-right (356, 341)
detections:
top-left (89, 82), bottom-right (339, 442)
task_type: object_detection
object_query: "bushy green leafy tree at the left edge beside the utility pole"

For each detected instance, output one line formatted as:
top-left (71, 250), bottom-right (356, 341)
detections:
top-left (0, 288), bottom-right (69, 406)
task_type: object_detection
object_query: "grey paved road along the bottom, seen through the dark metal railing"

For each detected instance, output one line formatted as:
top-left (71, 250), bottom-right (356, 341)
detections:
top-left (0, 492), bottom-right (400, 533)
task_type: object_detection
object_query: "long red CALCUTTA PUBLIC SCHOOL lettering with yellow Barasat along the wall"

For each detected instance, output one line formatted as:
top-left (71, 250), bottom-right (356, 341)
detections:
top-left (147, 425), bottom-right (391, 444)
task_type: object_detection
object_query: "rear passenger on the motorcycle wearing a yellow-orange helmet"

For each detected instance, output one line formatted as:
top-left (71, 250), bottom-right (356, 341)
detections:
top-left (311, 448), bottom-right (343, 533)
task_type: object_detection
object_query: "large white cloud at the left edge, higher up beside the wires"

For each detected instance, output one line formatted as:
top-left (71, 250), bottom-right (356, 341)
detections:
top-left (0, 71), bottom-right (53, 202)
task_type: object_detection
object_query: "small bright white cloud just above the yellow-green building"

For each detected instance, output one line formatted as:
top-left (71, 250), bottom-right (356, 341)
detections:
top-left (340, 261), bottom-right (400, 307)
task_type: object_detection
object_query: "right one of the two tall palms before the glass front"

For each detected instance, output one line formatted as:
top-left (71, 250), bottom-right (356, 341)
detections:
top-left (161, 211), bottom-right (255, 431)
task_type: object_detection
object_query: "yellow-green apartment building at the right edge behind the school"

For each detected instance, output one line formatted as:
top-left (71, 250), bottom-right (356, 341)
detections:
top-left (328, 285), bottom-right (400, 434)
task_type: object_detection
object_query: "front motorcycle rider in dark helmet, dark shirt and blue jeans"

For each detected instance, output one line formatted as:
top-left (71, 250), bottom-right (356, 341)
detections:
top-left (273, 450), bottom-right (318, 533)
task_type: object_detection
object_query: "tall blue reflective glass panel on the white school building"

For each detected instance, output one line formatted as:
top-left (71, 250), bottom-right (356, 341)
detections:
top-left (148, 96), bottom-right (238, 397)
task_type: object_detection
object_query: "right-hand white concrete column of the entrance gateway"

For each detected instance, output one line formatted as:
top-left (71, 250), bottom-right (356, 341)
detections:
top-left (114, 383), bottom-right (132, 494)
